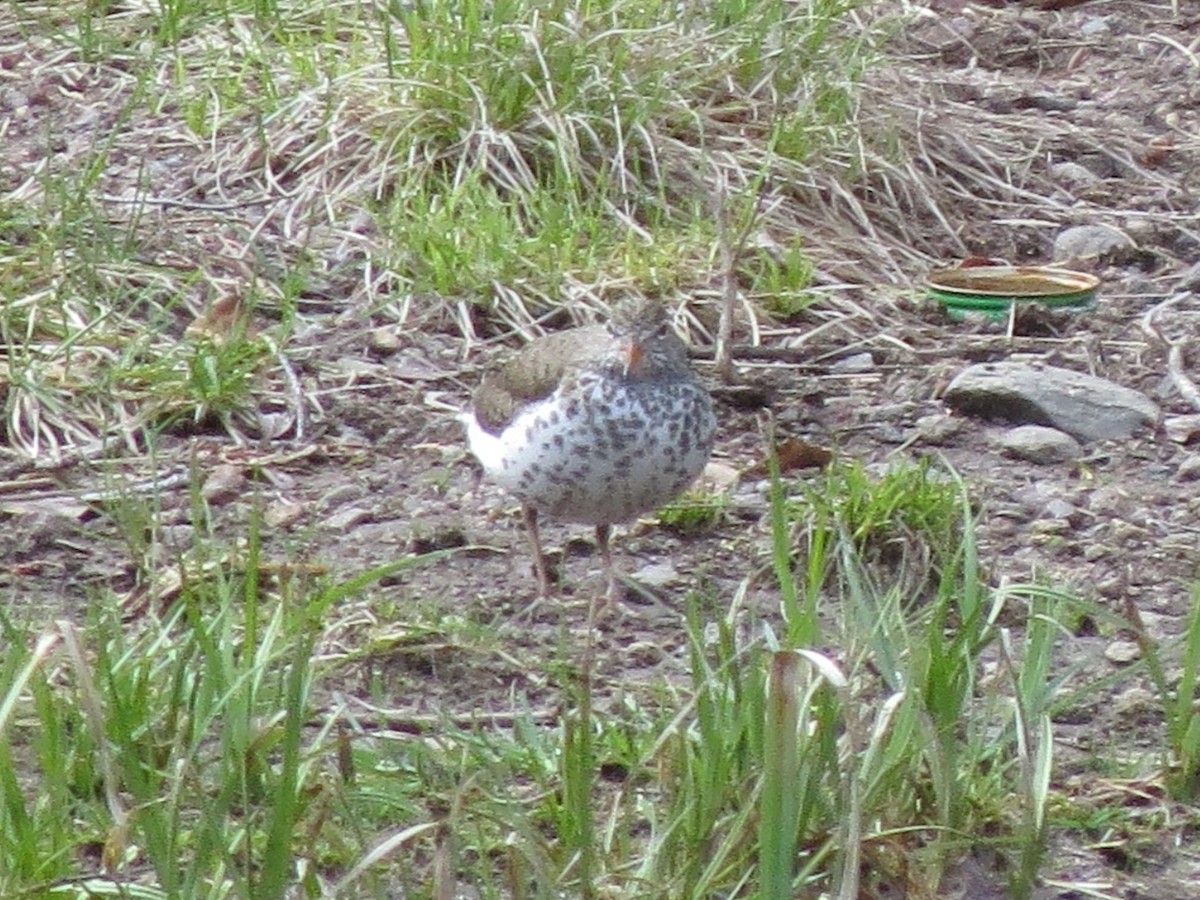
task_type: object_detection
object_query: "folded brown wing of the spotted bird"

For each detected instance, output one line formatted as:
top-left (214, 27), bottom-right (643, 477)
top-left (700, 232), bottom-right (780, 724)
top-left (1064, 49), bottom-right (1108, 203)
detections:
top-left (472, 325), bottom-right (612, 434)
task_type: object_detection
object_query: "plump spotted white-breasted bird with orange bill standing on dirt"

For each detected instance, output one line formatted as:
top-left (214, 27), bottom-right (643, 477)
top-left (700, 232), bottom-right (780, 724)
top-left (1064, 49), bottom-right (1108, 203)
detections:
top-left (464, 298), bottom-right (716, 607)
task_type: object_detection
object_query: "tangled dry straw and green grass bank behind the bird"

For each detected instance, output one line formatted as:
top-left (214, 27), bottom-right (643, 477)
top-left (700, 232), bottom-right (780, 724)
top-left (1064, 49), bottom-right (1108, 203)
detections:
top-left (0, 2), bottom-right (1200, 472)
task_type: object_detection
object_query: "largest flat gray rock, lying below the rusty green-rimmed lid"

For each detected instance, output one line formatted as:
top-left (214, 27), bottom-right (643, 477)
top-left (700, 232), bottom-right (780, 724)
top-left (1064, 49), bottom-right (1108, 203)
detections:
top-left (944, 362), bottom-right (1160, 440)
